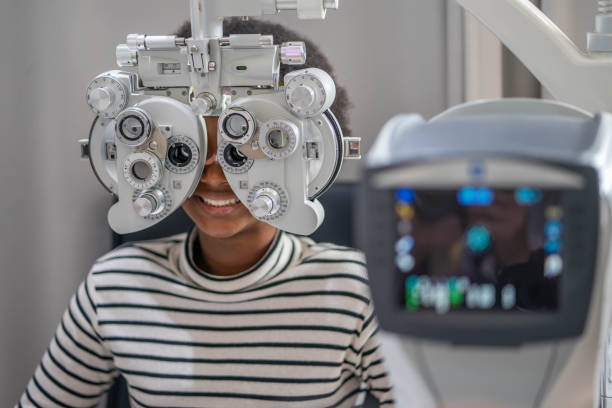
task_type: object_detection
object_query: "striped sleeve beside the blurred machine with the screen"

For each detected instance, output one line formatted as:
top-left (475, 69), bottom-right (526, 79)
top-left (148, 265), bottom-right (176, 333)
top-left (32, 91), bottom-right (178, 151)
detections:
top-left (354, 301), bottom-right (395, 408)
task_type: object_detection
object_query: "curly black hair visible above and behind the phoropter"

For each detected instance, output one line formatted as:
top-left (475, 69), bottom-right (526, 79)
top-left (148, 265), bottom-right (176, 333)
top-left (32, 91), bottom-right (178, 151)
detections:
top-left (175, 17), bottom-right (352, 136)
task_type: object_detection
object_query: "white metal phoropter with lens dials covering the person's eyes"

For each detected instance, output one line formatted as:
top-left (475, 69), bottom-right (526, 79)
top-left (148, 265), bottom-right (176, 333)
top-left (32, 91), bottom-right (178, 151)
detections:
top-left (81, 0), bottom-right (360, 235)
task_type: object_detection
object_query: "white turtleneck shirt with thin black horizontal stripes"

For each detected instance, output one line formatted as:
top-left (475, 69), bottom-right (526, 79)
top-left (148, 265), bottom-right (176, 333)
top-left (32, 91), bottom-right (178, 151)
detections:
top-left (19, 230), bottom-right (394, 408)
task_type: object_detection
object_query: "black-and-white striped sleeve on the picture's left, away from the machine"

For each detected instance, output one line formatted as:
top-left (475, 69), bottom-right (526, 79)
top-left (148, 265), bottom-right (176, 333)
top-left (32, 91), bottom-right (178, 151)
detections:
top-left (18, 274), bottom-right (118, 408)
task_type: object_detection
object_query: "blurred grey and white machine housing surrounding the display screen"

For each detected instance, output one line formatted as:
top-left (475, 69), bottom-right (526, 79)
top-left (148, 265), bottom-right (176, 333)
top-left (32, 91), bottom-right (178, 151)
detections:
top-left (358, 100), bottom-right (612, 408)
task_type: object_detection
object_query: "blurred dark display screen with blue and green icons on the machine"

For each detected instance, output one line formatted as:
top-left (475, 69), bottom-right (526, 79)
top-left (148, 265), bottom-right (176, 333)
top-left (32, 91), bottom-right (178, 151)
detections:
top-left (394, 186), bottom-right (567, 314)
